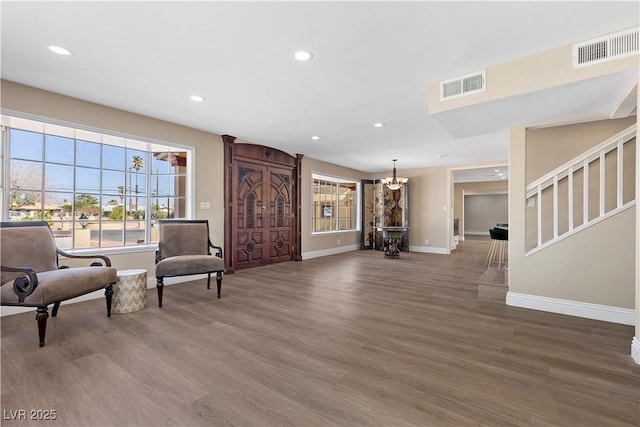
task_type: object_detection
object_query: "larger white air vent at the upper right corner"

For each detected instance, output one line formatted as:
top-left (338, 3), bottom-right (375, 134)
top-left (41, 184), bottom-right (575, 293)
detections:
top-left (573, 28), bottom-right (640, 68)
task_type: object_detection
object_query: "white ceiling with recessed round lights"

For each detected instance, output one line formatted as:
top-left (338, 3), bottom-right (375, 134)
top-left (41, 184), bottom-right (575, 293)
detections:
top-left (1, 1), bottom-right (640, 173)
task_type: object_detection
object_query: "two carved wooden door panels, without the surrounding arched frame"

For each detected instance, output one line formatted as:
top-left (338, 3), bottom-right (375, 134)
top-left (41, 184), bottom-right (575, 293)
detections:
top-left (232, 161), bottom-right (293, 268)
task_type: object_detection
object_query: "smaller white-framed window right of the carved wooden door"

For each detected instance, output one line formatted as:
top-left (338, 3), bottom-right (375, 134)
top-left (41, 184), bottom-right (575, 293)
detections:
top-left (312, 174), bottom-right (360, 233)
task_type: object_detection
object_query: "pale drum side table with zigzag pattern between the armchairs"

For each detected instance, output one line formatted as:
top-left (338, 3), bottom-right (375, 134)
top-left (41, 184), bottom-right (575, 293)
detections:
top-left (111, 269), bottom-right (147, 314)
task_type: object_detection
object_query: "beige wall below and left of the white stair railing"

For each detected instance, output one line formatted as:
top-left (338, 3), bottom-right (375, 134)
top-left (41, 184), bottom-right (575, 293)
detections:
top-left (508, 121), bottom-right (636, 309)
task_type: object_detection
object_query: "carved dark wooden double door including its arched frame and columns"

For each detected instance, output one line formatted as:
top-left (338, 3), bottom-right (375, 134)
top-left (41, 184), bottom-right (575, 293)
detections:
top-left (222, 135), bottom-right (303, 273)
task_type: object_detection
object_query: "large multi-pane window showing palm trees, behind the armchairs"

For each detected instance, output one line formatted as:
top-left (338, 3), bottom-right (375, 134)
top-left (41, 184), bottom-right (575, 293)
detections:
top-left (2, 116), bottom-right (192, 249)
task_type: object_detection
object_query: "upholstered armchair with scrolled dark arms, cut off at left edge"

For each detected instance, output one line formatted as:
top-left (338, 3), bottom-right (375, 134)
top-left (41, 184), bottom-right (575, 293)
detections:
top-left (0, 221), bottom-right (117, 347)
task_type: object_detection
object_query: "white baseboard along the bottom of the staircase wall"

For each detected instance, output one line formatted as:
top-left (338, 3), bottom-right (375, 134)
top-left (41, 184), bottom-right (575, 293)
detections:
top-left (507, 292), bottom-right (636, 326)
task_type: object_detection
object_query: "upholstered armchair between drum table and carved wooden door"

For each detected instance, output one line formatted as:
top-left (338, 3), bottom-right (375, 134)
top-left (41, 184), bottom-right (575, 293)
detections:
top-left (155, 219), bottom-right (224, 307)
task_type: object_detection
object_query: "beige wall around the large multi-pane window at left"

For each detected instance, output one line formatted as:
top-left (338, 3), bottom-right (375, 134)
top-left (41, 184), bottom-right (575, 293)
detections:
top-left (1, 80), bottom-right (224, 272)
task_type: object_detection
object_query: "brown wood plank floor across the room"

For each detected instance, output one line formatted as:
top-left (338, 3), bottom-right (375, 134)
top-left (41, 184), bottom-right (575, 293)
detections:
top-left (1, 241), bottom-right (640, 426)
